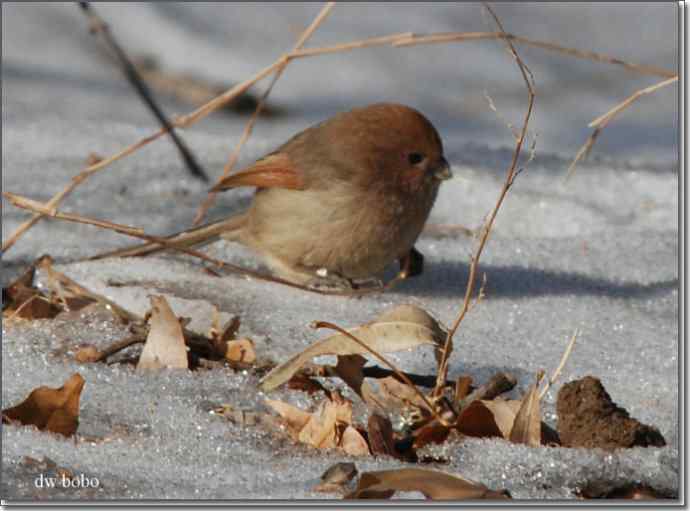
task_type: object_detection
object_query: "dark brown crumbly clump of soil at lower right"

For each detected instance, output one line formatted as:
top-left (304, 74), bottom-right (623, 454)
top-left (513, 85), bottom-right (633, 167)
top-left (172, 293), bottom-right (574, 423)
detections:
top-left (557, 376), bottom-right (666, 449)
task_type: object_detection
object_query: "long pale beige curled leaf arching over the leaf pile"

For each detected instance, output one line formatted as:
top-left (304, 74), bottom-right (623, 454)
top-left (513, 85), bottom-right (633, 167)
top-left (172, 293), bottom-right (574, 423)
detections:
top-left (260, 305), bottom-right (446, 392)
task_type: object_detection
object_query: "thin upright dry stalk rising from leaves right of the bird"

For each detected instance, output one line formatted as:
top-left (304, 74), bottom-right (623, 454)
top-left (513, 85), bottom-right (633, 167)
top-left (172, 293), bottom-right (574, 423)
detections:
top-left (432, 4), bottom-right (534, 397)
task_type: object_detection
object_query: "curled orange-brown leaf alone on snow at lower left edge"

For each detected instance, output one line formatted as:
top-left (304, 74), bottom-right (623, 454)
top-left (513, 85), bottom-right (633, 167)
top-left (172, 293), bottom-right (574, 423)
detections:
top-left (2, 373), bottom-right (84, 436)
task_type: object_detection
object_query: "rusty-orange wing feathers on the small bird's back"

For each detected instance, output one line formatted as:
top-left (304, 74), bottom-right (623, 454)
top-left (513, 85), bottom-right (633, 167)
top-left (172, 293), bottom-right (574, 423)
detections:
top-left (211, 153), bottom-right (305, 192)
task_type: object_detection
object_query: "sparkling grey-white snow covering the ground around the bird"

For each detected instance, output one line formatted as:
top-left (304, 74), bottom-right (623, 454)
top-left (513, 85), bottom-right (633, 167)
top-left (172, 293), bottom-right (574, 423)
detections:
top-left (1, 3), bottom-right (679, 499)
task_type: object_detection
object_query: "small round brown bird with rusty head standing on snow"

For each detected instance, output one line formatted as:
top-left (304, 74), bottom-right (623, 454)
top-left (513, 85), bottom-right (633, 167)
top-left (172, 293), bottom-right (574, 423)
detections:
top-left (98, 103), bottom-right (451, 287)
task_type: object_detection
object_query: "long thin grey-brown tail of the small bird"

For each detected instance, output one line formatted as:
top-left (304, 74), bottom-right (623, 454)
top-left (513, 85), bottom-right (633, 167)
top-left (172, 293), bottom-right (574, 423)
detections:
top-left (89, 214), bottom-right (245, 260)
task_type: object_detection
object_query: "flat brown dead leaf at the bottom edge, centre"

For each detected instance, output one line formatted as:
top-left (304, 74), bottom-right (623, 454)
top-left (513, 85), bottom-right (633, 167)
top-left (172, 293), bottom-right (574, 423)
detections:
top-left (345, 468), bottom-right (510, 500)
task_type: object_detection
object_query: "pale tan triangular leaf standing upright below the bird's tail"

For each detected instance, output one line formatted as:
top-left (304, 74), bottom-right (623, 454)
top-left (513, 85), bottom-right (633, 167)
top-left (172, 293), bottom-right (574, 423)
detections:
top-left (137, 296), bottom-right (189, 370)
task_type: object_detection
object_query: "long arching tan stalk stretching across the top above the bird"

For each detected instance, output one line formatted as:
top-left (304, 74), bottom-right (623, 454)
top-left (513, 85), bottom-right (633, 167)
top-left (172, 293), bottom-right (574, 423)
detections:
top-left (2, 2), bottom-right (677, 252)
